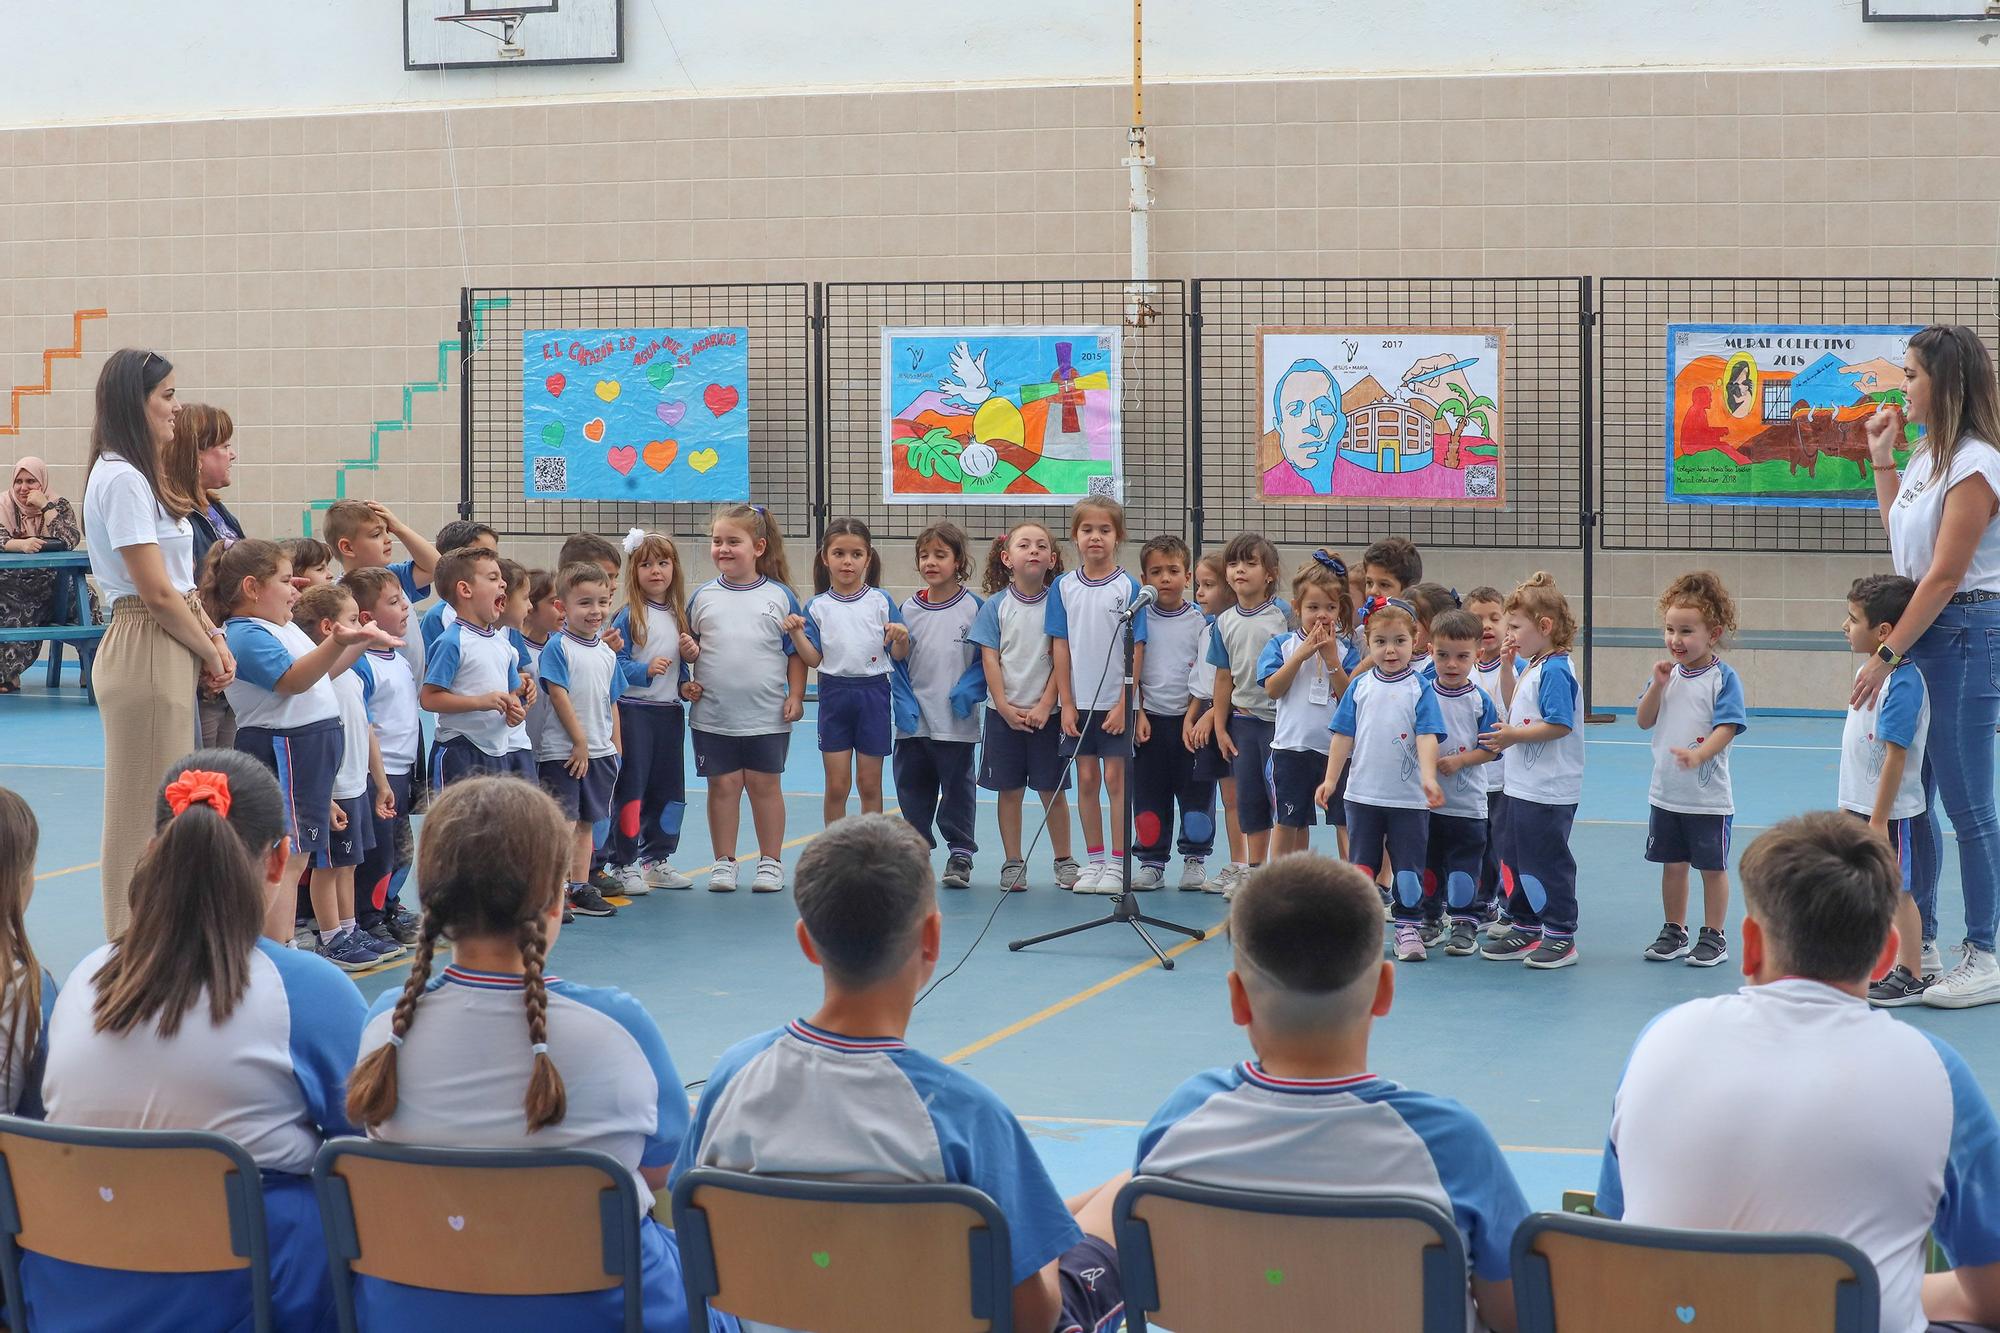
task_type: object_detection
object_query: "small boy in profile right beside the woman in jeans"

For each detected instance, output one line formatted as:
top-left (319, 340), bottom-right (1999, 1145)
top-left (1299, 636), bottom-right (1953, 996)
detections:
top-left (1840, 574), bottom-right (1938, 1009)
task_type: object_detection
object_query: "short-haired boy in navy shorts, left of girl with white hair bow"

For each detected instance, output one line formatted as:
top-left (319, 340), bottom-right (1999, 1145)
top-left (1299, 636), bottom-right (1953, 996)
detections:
top-left (536, 560), bottom-right (624, 917)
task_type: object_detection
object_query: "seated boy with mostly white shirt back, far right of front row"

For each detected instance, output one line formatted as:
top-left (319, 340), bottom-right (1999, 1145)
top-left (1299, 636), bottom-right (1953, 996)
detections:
top-left (1596, 811), bottom-right (2000, 1333)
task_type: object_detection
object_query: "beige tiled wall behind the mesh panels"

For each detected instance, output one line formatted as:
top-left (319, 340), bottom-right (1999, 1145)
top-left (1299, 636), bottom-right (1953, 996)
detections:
top-left (0, 66), bottom-right (2000, 705)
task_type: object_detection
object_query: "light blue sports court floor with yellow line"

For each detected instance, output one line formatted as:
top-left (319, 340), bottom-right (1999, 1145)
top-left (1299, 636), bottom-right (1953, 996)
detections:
top-left (0, 671), bottom-right (2000, 1207)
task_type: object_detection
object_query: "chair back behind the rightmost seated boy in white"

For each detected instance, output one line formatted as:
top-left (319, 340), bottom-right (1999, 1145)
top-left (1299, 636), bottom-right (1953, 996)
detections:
top-left (1514, 1213), bottom-right (1882, 1333)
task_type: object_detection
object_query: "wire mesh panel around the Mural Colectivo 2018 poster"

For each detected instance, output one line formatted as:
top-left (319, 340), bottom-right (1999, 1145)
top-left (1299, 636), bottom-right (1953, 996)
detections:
top-left (1598, 278), bottom-right (2000, 552)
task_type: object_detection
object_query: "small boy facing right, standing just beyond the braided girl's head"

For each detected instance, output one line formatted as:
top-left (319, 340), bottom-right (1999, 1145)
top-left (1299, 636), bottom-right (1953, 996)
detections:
top-left (418, 546), bottom-right (528, 793)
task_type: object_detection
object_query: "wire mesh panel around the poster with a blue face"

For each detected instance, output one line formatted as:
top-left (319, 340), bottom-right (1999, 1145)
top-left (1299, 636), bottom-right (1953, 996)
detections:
top-left (1194, 278), bottom-right (1590, 550)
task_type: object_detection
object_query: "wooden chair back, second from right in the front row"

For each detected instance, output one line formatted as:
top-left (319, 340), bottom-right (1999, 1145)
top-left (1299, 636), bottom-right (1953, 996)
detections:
top-left (1112, 1175), bottom-right (1468, 1333)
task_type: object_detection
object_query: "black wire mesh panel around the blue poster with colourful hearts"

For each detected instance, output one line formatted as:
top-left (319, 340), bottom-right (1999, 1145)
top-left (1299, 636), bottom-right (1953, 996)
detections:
top-left (460, 282), bottom-right (814, 536)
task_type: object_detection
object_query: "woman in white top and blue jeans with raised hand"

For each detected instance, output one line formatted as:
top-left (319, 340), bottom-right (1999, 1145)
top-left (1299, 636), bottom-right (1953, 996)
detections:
top-left (1854, 324), bottom-right (2000, 1009)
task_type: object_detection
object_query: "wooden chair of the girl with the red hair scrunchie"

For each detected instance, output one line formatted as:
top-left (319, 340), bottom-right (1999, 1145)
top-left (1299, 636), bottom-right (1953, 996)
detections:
top-left (0, 1115), bottom-right (272, 1333)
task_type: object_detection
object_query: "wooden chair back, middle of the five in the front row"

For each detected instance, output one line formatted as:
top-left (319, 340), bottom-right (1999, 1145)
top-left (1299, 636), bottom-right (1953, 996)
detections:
top-left (674, 1167), bottom-right (1014, 1333)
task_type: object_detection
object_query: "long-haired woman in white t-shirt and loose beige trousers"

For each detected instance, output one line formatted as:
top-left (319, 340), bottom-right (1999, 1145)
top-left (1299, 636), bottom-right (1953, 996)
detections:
top-left (84, 348), bottom-right (236, 939)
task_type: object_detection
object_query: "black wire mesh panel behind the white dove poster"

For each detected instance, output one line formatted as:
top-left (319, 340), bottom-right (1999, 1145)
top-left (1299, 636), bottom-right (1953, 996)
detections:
top-left (822, 280), bottom-right (1188, 544)
